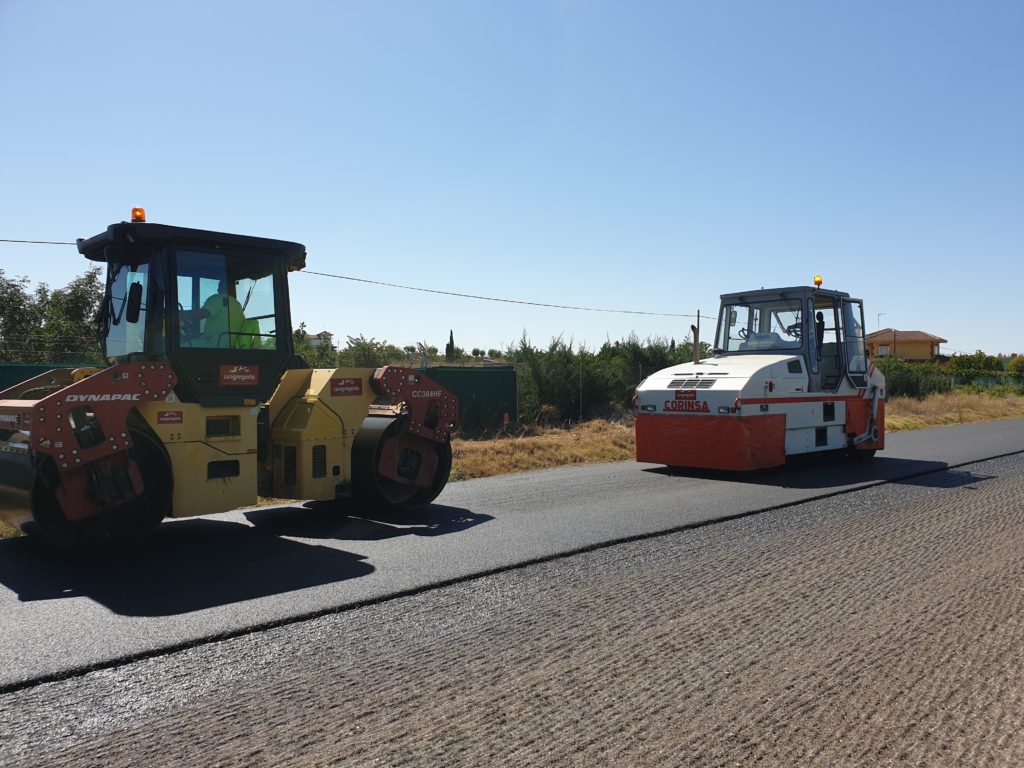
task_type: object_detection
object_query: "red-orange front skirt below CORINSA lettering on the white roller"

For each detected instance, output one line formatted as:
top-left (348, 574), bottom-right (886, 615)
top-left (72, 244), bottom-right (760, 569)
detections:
top-left (636, 414), bottom-right (785, 470)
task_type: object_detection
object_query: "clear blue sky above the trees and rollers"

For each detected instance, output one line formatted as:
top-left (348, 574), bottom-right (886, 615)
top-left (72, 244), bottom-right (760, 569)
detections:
top-left (0, 0), bottom-right (1024, 354)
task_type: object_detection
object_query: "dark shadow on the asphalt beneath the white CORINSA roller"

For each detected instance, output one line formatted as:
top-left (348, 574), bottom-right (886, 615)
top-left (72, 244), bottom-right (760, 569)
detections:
top-left (644, 455), bottom-right (962, 490)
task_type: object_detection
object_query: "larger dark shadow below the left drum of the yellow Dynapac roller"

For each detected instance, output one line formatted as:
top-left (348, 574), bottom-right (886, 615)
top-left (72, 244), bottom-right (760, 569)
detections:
top-left (0, 519), bottom-right (375, 616)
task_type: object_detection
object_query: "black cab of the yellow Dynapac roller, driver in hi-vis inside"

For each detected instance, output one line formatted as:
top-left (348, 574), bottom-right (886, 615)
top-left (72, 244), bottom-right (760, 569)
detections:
top-left (78, 204), bottom-right (306, 407)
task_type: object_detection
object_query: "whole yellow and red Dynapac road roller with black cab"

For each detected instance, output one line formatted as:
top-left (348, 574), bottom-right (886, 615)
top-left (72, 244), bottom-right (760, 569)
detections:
top-left (0, 209), bottom-right (458, 551)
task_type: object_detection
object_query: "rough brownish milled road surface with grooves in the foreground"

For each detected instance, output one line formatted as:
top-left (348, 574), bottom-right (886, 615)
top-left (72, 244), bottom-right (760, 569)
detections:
top-left (0, 457), bottom-right (1024, 767)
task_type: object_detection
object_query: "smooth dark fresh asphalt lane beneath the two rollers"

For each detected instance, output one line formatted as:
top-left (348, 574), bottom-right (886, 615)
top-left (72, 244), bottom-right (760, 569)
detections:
top-left (0, 419), bottom-right (1024, 691)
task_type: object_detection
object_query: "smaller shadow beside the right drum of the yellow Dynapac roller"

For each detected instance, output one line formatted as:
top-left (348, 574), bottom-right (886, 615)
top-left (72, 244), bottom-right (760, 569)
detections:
top-left (245, 500), bottom-right (495, 542)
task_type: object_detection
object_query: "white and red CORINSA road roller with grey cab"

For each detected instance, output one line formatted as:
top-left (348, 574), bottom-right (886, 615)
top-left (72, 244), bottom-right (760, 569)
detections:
top-left (634, 275), bottom-right (886, 470)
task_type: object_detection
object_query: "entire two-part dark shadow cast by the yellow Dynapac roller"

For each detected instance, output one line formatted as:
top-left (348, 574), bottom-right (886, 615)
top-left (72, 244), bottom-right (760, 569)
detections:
top-left (0, 502), bottom-right (494, 616)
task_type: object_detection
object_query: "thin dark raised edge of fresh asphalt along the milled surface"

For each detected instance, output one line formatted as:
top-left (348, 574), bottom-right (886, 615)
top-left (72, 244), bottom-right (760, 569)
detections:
top-left (0, 451), bottom-right (1024, 695)
